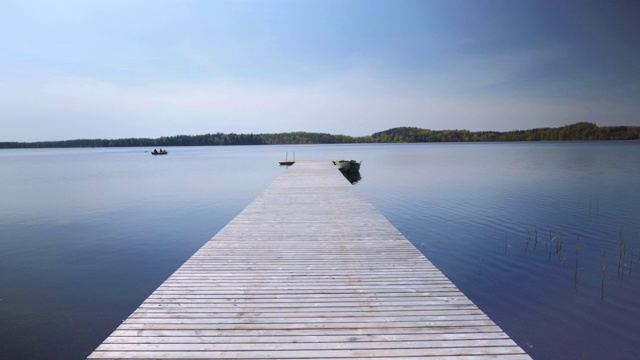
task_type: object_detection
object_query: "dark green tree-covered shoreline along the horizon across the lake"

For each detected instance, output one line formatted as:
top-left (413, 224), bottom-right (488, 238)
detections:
top-left (0, 122), bottom-right (640, 149)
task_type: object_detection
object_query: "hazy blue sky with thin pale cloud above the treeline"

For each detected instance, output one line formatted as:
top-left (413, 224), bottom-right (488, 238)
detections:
top-left (0, 0), bottom-right (640, 142)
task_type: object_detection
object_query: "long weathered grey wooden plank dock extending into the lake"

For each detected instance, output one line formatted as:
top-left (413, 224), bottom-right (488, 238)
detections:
top-left (89, 160), bottom-right (530, 359)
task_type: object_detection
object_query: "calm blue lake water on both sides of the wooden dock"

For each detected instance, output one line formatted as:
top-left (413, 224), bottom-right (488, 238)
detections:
top-left (0, 142), bottom-right (640, 359)
